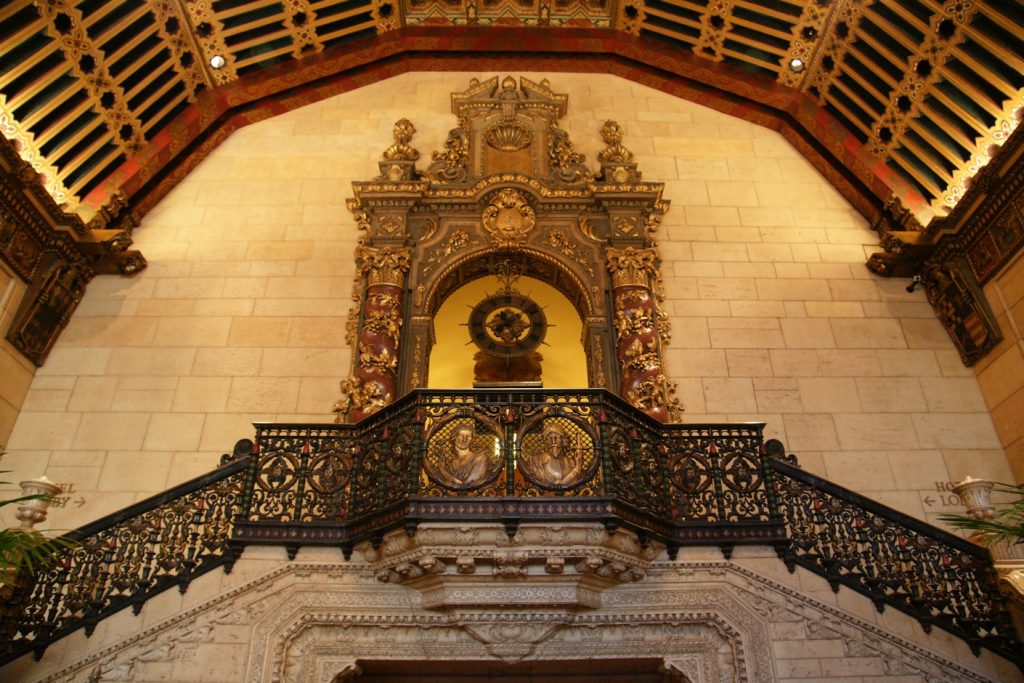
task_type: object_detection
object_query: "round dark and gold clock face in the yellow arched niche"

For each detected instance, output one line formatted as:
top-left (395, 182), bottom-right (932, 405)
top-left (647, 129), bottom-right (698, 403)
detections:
top-left (469, 293), bottom-right (548, 358)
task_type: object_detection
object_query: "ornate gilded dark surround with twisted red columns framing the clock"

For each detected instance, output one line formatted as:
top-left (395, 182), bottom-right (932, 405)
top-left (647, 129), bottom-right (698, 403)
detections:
top-left (335, 76), bottom-right (681, 423)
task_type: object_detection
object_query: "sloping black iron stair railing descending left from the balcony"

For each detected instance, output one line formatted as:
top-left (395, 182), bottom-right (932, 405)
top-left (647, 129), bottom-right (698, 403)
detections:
top-left (0, 440), bottom-right (252, 661)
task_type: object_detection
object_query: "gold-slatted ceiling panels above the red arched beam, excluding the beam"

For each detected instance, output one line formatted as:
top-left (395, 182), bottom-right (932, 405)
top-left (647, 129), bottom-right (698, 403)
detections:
top-left (0, 0), bottom-right (1024, 222)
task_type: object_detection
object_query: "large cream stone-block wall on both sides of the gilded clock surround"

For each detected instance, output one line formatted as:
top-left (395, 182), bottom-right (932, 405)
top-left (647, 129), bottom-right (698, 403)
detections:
top-left (3, 74), bottom-right (1010, 526)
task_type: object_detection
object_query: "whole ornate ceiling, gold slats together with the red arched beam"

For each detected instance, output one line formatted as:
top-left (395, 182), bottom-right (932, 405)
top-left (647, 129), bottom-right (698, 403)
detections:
top-left (0, 0), bottom-right (1024, 221)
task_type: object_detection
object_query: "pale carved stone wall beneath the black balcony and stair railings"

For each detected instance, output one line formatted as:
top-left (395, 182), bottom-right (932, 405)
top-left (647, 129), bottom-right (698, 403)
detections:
top-left (0, 524), bottom-right (1020, 683)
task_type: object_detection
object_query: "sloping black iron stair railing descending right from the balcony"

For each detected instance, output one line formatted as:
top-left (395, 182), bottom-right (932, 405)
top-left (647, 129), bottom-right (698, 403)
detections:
top-left (768, 448), bottom-right (1024, 663)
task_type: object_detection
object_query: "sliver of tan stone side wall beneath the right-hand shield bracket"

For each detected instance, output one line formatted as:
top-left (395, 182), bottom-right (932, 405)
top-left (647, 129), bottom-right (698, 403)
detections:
top-left (975, 255), bottom-right (1024, 483)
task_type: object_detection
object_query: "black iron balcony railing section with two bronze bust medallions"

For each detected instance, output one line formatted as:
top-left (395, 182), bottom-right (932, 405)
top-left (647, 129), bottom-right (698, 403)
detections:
top-left (234, 389), bottom-right (784, 555)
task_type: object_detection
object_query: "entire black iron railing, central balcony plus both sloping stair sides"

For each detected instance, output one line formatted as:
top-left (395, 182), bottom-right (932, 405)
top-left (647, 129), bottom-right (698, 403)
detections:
top-left (0, 389), bottom-right (1024, 664)
